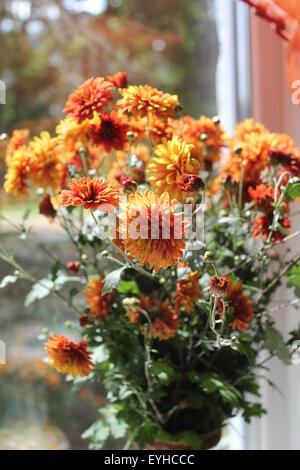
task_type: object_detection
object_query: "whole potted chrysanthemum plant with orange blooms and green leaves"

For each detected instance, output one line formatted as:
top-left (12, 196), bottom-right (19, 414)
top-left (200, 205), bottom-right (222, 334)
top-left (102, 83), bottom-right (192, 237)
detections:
top-left (0, 73), bottom-right (300, 449)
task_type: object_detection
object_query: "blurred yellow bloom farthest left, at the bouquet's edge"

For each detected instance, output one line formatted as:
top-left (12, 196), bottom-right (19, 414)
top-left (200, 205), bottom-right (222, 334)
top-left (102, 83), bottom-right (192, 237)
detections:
top-left (4, 146), bottom-right (32, 197)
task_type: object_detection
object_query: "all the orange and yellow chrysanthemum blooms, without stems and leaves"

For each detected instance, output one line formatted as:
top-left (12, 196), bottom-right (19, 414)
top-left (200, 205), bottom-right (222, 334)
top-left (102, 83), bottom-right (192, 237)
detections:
top-left (4, 73), bottom-right (300, 377)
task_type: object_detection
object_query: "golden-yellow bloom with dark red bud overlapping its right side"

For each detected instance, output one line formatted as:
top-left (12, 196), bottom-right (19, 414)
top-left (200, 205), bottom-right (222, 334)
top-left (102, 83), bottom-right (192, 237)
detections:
top-left (147, 136), bottom-right (200, 202)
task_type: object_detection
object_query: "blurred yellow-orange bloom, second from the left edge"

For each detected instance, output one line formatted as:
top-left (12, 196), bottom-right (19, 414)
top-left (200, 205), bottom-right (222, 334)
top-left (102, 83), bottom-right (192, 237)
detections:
top-left (29, 132), bottom-right (63, 189)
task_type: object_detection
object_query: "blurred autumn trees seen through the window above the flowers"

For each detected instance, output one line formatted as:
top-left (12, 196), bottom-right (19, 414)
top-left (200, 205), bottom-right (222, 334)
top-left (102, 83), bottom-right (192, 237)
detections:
top-left (0, 0), bottom-right (218, 132)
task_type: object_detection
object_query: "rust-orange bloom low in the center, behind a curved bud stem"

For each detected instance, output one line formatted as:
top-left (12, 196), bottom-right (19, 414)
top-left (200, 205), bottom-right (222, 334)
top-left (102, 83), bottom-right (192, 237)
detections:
top-left (126, 295), bottom-right (180, 341)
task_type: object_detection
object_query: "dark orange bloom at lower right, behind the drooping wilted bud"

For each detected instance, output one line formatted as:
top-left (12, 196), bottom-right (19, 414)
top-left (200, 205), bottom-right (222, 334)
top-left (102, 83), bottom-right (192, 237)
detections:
top-left (219, 279), bottom-right (253, 331)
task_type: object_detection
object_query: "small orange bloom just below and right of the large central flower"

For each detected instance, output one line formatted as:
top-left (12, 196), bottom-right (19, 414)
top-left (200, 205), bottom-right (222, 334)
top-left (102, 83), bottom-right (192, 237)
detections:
top-left (174, 271), bottom-right (202, 313)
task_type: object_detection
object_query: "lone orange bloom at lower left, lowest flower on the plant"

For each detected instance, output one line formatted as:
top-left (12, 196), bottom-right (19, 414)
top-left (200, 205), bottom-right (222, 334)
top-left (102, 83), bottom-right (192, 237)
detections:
top-left (45, 335), bottom-right (95, 377)
